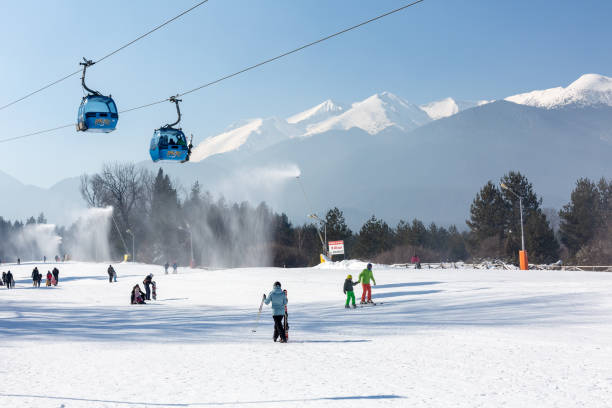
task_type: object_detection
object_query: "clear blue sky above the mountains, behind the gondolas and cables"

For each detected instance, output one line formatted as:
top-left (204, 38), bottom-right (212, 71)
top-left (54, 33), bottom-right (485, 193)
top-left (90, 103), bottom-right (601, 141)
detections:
top-left (0, 0), bottom-right (612, 186)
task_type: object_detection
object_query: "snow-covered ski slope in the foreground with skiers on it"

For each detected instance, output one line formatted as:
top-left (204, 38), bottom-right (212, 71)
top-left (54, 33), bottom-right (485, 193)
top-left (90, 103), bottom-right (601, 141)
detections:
top-left (0, 262), bottom-right (612, 408)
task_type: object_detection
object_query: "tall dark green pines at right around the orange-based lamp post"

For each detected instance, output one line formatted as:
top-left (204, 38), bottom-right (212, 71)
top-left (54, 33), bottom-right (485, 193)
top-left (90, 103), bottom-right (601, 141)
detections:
top-left (467, 172), bottom-right (612, 265)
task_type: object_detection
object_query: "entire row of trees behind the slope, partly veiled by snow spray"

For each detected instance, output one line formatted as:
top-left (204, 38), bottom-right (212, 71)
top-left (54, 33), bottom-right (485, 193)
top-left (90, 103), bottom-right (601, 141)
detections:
top-left (0, 164), bottom-right (612, 267)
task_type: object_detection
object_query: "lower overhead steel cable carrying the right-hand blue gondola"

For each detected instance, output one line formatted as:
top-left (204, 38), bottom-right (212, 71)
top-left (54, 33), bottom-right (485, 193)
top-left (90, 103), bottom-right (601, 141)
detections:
top-left (0, 0), bottom-right (425, 143)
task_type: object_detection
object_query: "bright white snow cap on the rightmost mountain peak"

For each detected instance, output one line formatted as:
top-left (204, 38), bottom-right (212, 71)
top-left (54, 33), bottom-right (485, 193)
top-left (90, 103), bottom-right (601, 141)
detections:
top-left (506, 74), bottom-right (612, 109)
